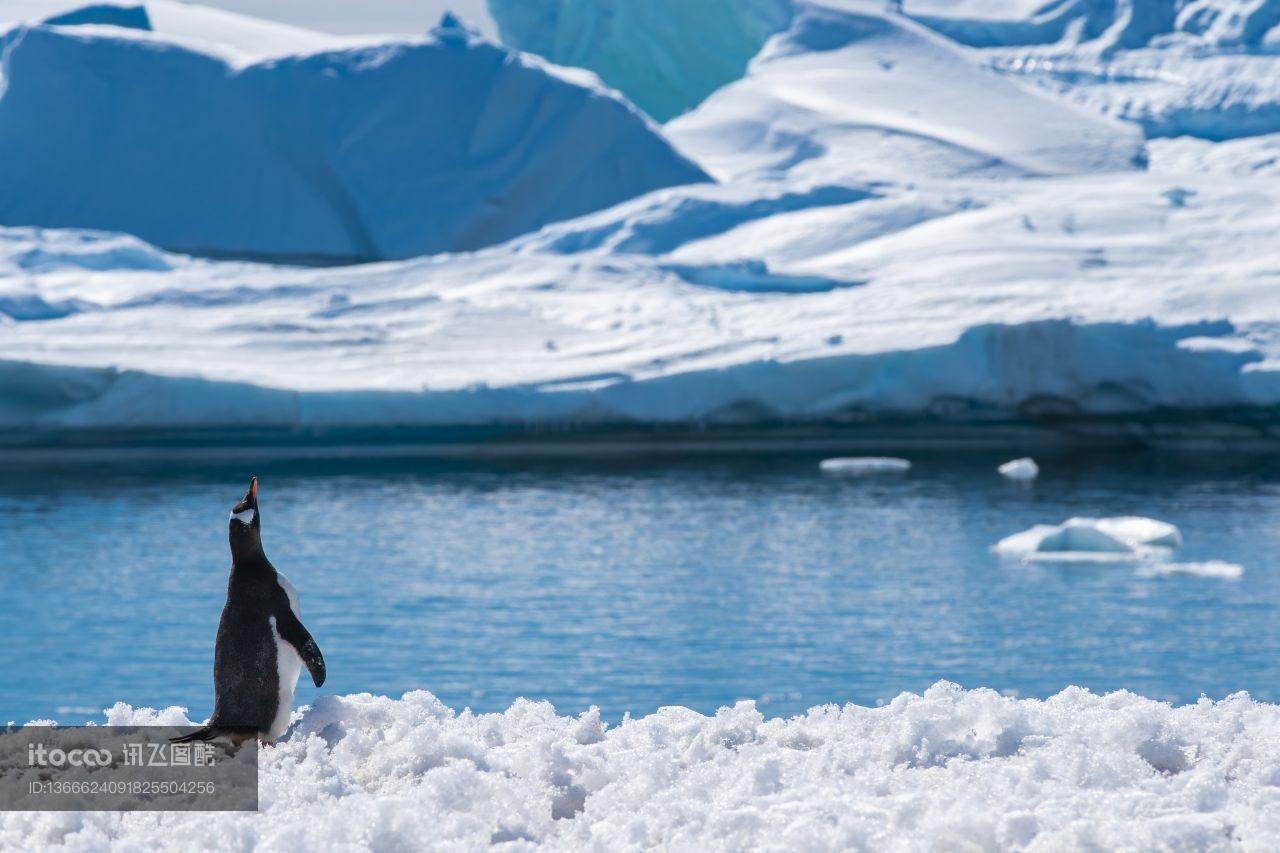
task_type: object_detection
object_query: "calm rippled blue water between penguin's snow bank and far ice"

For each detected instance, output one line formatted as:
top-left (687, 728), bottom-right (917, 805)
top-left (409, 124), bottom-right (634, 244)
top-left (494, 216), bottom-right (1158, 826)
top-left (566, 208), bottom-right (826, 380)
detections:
top-left (0, 456), bottom-right (1280, 722)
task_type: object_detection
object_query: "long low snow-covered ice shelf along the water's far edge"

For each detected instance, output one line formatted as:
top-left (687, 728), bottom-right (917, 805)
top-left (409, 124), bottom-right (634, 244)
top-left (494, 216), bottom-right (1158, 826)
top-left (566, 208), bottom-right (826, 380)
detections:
top-left (0, 149), bottom-right (1280, 440)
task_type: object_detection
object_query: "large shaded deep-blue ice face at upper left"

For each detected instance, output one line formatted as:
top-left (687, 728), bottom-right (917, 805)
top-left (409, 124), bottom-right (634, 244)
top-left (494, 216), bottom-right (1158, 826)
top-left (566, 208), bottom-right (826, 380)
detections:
top-left (0, 6), bottom-right (705, 263)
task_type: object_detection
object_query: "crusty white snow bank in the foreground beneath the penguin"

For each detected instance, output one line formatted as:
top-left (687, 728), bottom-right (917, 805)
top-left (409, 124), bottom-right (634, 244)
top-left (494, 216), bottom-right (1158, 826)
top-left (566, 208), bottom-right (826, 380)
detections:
top-left (10, 683), bottom-right (1280, 850)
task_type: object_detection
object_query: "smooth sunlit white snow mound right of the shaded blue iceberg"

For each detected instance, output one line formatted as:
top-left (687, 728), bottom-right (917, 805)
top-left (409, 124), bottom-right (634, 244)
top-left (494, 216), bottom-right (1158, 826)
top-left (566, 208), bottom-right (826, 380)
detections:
top-left (667, 0), bottom-right (1143, 181)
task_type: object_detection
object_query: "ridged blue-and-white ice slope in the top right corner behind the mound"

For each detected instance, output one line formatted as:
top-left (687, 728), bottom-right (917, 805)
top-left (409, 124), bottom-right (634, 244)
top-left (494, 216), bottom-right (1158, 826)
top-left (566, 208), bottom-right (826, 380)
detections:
top-left (909, 0), bottom-right (1280, 140)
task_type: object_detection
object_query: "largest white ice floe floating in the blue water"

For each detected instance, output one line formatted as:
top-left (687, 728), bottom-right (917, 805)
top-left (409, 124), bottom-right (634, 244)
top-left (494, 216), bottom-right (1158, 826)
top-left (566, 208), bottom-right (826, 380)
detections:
top-left (996, 515), bottom-right (1183, 562)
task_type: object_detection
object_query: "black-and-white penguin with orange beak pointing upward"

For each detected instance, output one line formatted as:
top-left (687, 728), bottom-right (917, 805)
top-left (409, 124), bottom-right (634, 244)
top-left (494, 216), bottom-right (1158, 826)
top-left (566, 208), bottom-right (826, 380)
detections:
top-left (174, 476), bottom-right (325, 743)
